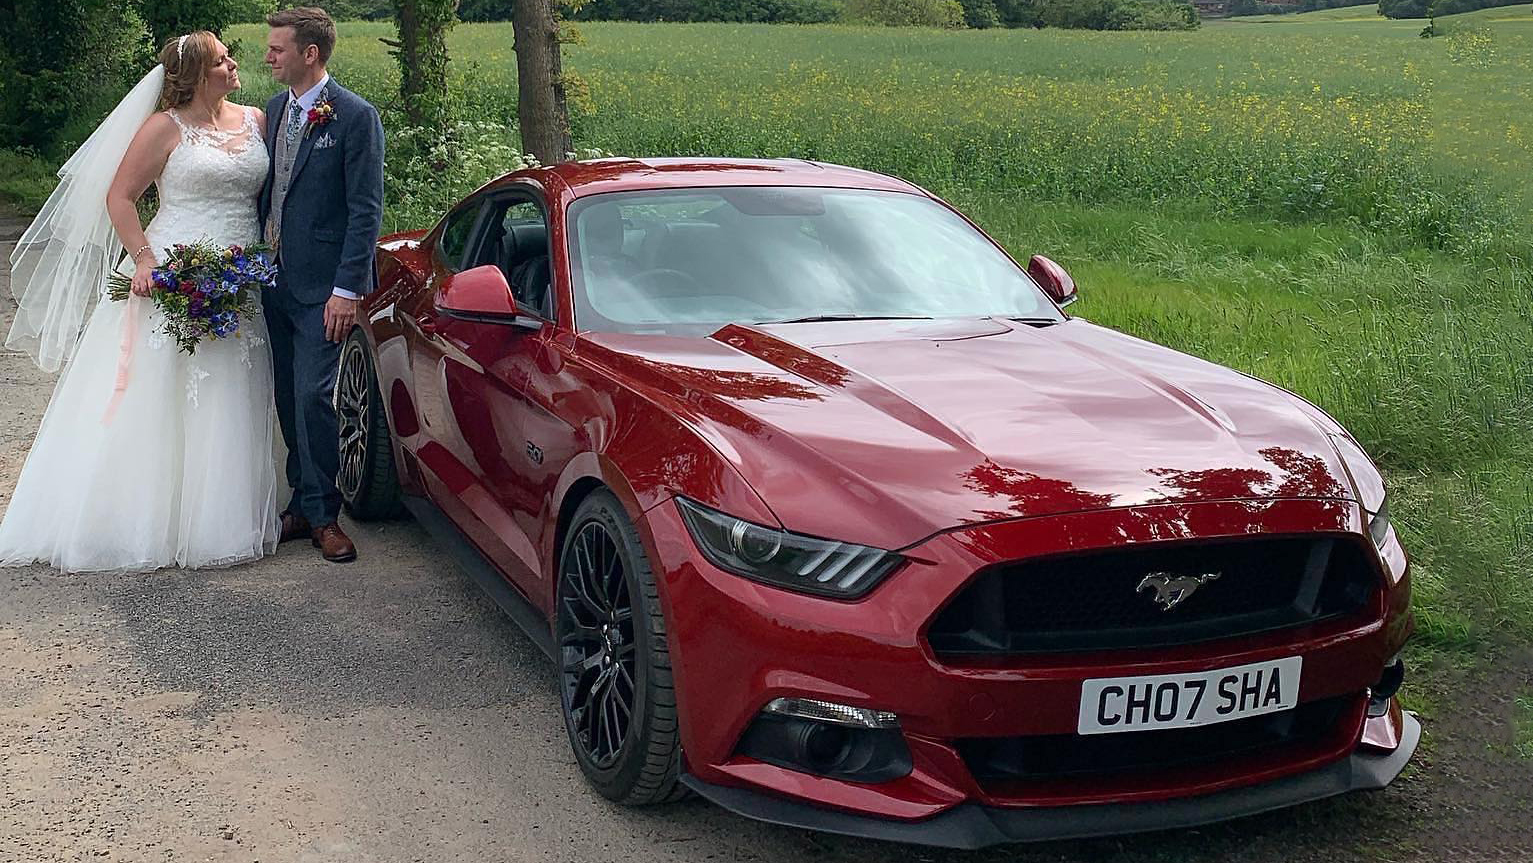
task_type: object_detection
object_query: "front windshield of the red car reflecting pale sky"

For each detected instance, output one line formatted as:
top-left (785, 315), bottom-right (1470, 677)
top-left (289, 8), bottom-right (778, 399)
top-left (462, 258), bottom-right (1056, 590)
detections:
top-left (567, 187), bottom-right (1062, 334)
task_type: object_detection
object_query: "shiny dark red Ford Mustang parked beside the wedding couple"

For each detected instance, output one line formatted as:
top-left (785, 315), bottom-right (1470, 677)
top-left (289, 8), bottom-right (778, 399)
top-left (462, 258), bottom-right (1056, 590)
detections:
top-left (336, 159), bottom-right (1420, 848)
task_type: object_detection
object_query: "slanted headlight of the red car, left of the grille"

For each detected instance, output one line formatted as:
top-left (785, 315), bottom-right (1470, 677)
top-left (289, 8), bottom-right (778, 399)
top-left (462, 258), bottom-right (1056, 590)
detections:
top-left (676, 497), bottom-right (904, 599)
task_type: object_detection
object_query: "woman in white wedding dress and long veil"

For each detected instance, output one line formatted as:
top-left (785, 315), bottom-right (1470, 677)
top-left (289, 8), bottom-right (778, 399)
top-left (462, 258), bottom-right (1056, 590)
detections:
top-left (0, 32), bottom-right (277, 572)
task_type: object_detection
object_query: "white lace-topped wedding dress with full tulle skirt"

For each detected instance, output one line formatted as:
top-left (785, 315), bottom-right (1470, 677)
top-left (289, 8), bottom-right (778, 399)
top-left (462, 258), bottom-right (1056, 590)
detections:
top-left (0, 109), bottom-right (277, 572)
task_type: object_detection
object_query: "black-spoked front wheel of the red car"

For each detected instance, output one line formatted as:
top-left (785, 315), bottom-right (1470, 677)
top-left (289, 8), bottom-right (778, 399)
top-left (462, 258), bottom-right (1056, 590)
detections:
top-left (553, 489), bottom-right (685, 806)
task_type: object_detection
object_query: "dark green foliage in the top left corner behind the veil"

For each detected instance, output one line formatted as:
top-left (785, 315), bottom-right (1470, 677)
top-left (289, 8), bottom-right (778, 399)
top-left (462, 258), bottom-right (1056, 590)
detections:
top-left (0, 0), bottom-right (150, 155)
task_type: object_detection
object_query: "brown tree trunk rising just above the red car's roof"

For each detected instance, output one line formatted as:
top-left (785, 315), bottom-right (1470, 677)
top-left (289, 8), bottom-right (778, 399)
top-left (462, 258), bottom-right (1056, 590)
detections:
top-left (510, 0), bottom-right (573, 166)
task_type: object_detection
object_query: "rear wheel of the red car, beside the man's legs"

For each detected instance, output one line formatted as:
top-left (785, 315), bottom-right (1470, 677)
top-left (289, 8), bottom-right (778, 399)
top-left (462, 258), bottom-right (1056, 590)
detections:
top-left (336, 330), bottom-right (403, 521)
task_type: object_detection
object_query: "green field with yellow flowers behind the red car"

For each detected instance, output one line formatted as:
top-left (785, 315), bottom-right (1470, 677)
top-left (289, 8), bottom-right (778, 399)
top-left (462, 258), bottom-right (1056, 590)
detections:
top-left (194, 6), bottom-right (1533, 665)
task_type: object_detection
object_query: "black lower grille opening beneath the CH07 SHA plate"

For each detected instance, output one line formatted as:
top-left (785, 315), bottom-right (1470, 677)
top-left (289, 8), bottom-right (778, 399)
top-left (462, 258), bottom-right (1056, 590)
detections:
top-left (958, 696), bottom-right (1358, 785)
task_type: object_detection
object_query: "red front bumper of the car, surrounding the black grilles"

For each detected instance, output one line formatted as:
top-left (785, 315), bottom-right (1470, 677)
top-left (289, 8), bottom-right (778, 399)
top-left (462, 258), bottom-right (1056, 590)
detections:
top-left (641, 500), bottom-right (1413, 845)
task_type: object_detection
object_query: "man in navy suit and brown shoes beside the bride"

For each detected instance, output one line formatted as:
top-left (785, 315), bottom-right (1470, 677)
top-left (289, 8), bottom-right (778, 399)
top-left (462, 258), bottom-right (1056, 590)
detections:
top-left (261, 6), bottom-right (383, 563)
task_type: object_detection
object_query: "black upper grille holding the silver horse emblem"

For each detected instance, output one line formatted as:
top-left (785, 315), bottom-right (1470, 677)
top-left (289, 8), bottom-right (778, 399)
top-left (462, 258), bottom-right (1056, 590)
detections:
top-left (927, 537), bottom-right (1377, 655)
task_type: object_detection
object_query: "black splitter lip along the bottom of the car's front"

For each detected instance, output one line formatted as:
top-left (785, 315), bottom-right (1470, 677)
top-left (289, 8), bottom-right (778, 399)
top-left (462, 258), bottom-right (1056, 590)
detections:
top-left (682, 714), bottom-right (1421, 849)
